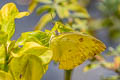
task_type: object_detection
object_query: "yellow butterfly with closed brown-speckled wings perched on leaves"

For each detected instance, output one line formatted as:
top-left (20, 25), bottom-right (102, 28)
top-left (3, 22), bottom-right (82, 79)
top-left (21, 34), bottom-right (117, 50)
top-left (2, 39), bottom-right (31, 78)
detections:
top-left (50, 32), bottom-right (106, 70)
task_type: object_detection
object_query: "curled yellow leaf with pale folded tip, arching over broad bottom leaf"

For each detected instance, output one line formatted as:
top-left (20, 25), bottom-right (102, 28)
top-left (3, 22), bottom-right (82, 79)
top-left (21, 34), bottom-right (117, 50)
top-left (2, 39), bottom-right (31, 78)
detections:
top-left (13, 42), bottom-right (52, 65)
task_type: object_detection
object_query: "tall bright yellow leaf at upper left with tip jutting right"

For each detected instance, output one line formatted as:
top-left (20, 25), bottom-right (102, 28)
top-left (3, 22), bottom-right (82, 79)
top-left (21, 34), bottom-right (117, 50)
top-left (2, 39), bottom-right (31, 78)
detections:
top-left (1, 3), bottom-right (28, 40)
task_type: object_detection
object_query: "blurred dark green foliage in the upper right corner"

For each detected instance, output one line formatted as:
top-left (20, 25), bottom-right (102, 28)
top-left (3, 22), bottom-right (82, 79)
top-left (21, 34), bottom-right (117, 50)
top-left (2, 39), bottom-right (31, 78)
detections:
top-left (90, 0), bottom-right (120, 40)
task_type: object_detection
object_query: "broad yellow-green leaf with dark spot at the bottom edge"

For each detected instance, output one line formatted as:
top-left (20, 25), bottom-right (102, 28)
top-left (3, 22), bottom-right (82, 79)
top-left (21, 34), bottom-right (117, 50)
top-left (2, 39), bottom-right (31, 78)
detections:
top-left (9, 54), bottom-right (44, 80)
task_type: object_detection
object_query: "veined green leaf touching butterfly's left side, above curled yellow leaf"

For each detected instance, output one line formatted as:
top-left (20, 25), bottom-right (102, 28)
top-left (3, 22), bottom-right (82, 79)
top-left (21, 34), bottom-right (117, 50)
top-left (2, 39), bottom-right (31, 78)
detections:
top-left (16, 31), bottom-right (51, 46)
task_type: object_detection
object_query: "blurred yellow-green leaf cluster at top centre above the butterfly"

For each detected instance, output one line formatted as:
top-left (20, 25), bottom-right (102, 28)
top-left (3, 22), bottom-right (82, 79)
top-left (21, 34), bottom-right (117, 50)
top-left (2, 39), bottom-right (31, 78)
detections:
top-left (28, 0), bottom-right (90, 31)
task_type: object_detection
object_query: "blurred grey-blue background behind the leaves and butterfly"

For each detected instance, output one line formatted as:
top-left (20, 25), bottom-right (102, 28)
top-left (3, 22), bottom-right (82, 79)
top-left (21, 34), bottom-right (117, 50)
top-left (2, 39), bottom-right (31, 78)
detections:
top-left (0, 0), bottom-right (120, 80)
